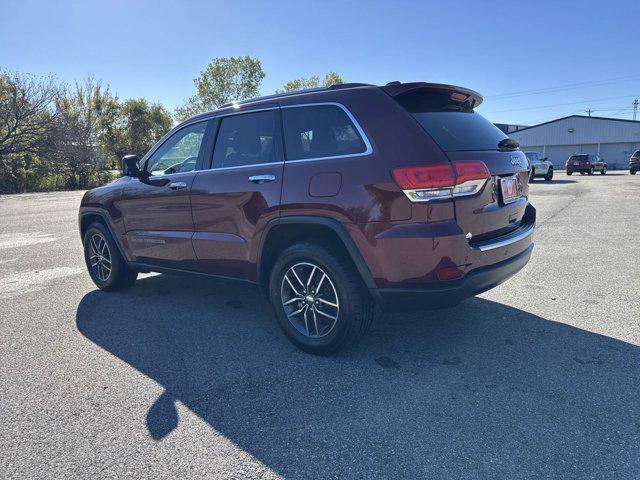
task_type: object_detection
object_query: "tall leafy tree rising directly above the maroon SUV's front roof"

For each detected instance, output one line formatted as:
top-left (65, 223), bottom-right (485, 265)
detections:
top-left (175, 55), bottom-right (265, 120)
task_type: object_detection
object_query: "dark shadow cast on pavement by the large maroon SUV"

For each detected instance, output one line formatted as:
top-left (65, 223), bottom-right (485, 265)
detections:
top-left (77, 275), bottom-right (640, 479)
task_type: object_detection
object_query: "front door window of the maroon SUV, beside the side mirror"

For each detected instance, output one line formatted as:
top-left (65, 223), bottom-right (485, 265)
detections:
top-left (146, 121), bottom-right (207, 175)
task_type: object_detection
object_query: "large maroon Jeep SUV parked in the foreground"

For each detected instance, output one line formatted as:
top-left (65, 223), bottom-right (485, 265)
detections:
top-left (80, 82), bottom-right (536, 354)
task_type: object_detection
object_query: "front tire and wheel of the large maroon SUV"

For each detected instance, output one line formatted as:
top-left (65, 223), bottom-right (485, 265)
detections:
top-left (83, 222), bottom-right (138, 292)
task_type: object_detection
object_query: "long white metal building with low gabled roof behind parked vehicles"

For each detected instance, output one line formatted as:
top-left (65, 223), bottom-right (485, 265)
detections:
top-left (509, 115), bottom-right (640, 169)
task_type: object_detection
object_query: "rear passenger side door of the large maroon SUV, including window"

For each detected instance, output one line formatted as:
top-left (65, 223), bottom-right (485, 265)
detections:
top-left (191, 106), bottom-right (284, 280)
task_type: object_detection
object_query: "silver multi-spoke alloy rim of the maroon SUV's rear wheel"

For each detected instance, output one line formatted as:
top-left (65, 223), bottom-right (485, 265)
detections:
top-left (280, 262), bottom-right (340, 338)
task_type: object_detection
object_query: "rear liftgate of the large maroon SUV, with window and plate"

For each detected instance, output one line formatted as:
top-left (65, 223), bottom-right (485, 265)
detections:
top-left (412, 104), bottom-right (528, 240)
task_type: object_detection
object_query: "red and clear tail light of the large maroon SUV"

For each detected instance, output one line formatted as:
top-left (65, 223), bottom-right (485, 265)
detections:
top-left (391, 160), bottom-right (489, 202)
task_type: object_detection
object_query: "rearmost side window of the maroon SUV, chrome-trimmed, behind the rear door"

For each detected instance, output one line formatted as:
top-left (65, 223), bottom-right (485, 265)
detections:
top-left (282, 105), bottom-right (367, 160)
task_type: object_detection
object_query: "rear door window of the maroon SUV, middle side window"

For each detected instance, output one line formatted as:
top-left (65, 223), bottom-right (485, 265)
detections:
top-left (213, 110), bottom-right (277, 168)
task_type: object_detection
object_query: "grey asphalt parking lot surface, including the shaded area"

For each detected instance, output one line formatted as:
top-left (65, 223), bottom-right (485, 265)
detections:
top-left (0, 172), bottom-right (640, 479)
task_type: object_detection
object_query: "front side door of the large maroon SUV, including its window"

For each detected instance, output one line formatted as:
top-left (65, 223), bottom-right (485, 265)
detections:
top-left (118, 121), bottom-right (209, 269)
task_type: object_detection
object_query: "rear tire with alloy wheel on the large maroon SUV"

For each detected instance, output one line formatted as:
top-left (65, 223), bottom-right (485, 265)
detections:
top-left (269, 242), bottom-right (374, 355)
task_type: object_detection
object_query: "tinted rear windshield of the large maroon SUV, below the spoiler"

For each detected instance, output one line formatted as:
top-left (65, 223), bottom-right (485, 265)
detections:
top-left (396, 90), bottom-right (508, 152)
